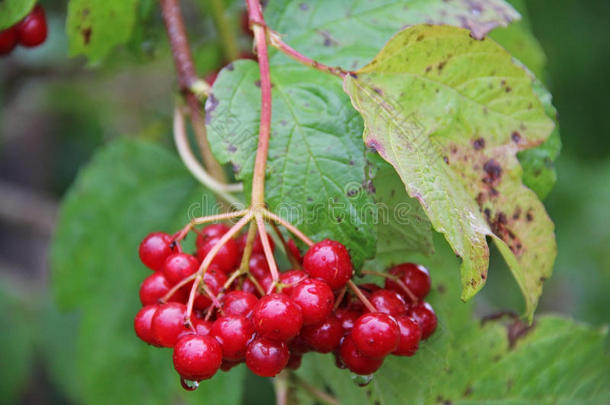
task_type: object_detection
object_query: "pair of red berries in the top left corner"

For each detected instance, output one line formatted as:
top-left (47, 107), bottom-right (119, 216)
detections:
top-left (0, 4), bottom-right (47, 55)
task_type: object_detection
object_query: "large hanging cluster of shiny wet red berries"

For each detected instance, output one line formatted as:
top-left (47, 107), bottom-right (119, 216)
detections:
top-left (135, 224), bottom-right (436, 389)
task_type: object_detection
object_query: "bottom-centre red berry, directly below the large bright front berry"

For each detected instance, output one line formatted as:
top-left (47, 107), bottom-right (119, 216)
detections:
top-left (246, 337), bottom-right (290, 377)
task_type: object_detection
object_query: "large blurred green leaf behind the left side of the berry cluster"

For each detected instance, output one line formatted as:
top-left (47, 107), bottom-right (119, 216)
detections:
top-left (51, 140), bottom-right (243, 404)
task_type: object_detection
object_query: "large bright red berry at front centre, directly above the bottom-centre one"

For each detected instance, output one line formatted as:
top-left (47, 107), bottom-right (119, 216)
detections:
top-left (252, 294), bottom-right (303, 342)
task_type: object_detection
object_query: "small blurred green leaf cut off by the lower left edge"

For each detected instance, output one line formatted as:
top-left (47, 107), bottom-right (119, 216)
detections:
top-left (0, 280), bottom-right (35, 404)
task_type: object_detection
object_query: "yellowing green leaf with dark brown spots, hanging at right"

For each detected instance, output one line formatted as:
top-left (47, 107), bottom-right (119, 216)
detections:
top-left (344, 26), bottom-right (556, 318)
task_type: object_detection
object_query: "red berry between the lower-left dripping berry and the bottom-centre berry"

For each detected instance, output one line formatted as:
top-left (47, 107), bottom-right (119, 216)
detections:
top-left (212, 315), bottom-right (254, 361)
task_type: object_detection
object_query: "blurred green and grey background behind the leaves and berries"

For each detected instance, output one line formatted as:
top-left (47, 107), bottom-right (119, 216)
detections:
top-left (0, 0), bottom-right (610, 404)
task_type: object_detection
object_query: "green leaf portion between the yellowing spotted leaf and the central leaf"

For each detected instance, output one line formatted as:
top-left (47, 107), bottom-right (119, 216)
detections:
top-left (367, 154), bottom-right (434, 269)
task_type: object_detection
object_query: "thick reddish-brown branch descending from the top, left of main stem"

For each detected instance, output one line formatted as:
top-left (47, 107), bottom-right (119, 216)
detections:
top-left (160, 0), bottom-right (226, 182)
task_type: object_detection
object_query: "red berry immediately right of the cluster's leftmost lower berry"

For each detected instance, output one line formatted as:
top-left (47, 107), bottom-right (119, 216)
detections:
top-left (151, 302), bottom-right (192, 347)
